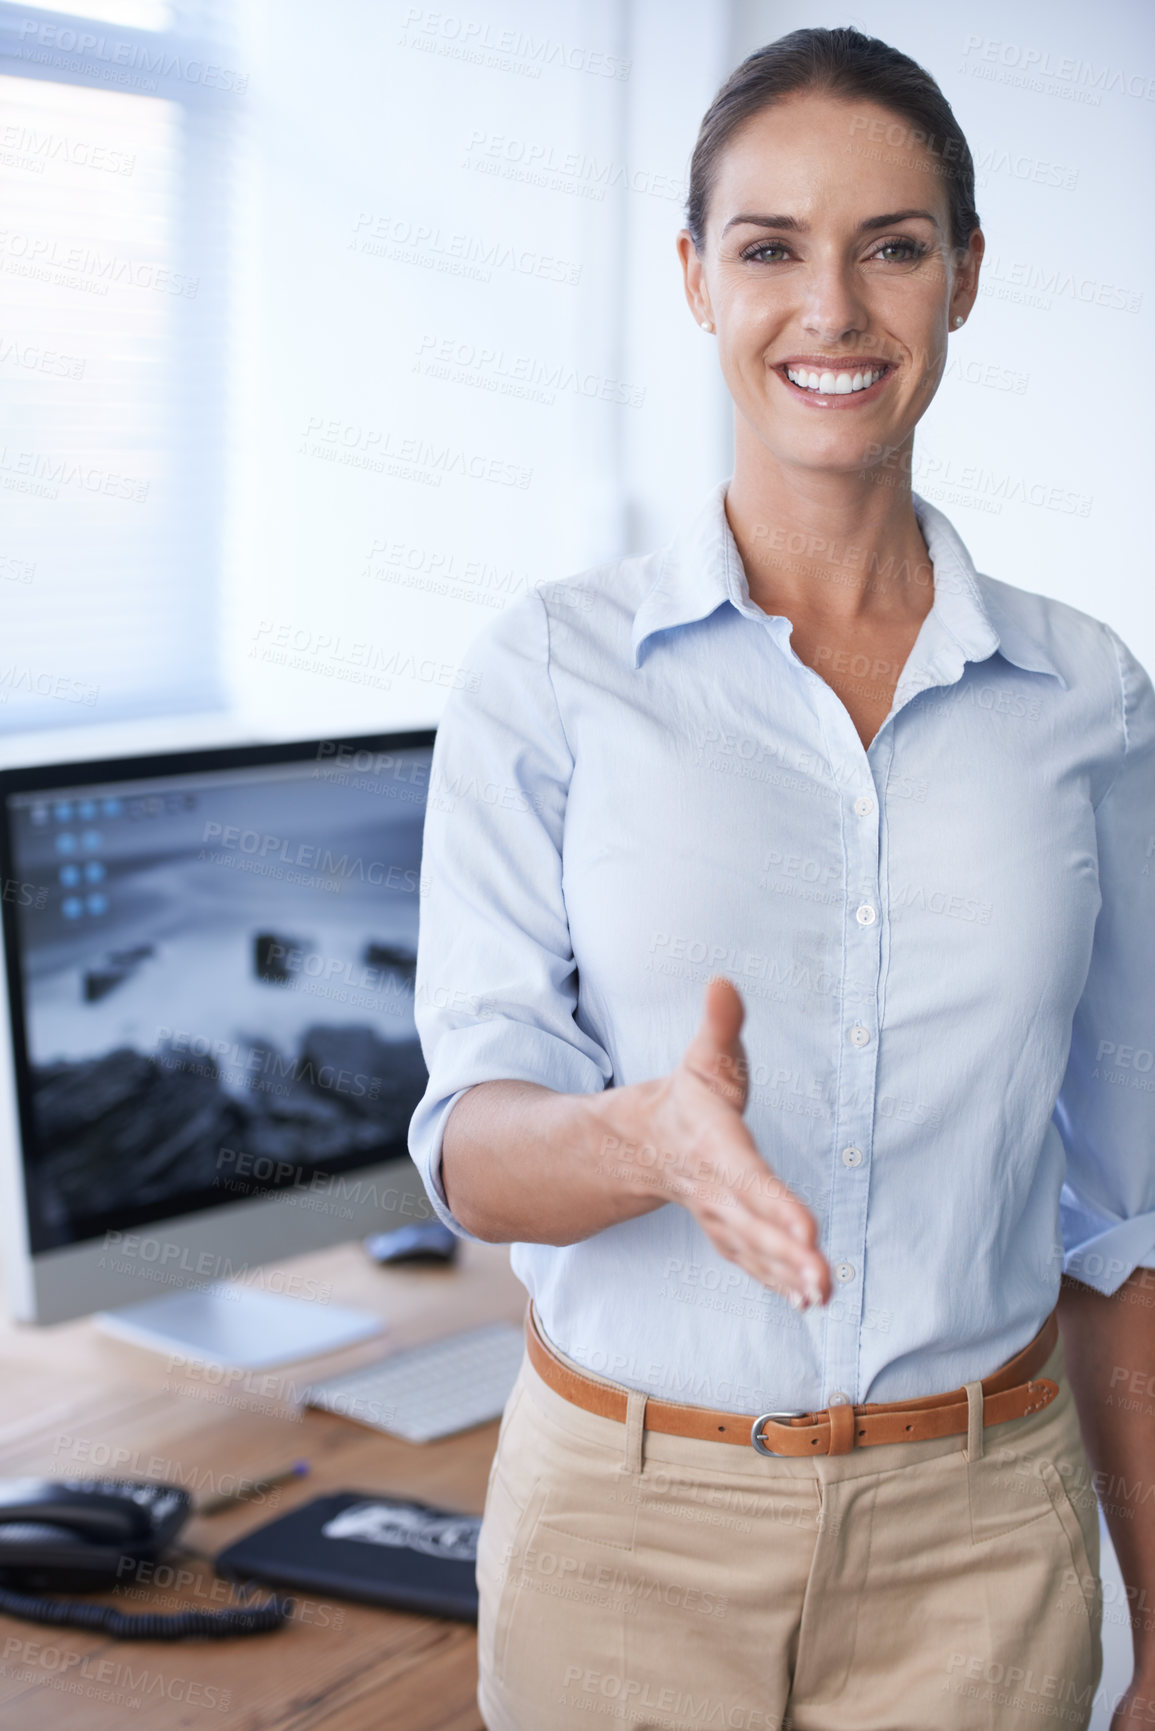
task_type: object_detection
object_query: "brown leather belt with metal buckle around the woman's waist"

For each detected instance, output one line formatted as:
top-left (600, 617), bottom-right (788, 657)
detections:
top-left (525, 1300), bottom-right (1058, 1458)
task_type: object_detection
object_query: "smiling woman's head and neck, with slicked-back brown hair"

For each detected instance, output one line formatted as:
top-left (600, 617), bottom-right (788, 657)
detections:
top-left (679, 43), bottom-right (984, 746)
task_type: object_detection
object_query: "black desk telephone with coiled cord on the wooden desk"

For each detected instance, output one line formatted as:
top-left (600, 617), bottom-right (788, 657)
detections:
top-left (0, 1478), bottom-right (287, 1641)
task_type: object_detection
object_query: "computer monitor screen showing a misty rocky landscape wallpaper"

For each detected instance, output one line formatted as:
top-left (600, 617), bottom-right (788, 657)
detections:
top-left (3, 734), bottom-right (431, 1253)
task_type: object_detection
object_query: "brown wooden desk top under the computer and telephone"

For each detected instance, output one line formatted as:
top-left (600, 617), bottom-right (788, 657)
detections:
top-left (0, 1241), bottom-right (525, 1731)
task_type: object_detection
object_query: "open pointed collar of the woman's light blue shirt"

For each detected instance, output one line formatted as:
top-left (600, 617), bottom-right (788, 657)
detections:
top-left (630, 481), bottom-right (1067, 687)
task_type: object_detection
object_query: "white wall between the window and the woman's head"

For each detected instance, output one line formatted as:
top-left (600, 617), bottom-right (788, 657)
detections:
top-left (227, 0), bottom-right (727, 734)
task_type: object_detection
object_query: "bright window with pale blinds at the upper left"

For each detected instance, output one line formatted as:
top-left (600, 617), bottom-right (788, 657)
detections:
top-left (0, 0), bottom-right (242, 732)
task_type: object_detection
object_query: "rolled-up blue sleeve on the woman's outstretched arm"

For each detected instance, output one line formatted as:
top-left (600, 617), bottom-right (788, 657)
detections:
top-left (409, 592), bottom-right (613, 1238)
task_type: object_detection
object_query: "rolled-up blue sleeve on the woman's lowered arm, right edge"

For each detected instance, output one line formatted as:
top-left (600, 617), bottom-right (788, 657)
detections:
top-left (1055, 632), bottom-right (1155, 1293)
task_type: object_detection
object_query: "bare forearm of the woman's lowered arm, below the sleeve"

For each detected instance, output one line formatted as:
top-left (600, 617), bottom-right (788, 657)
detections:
top-left (1058, 1269), bottom-right (1155, 1726)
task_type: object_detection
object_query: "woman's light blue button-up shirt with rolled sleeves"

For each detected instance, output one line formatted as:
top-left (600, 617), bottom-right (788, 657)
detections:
top-left (410, 486), bottom-right (1155, 1412)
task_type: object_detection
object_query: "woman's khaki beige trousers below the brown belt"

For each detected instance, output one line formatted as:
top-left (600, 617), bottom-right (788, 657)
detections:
top-left (478, 1315), bottom-right (1101, 1731)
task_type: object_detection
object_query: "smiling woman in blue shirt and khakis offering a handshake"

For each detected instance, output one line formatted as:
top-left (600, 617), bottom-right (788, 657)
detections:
top-left (410, 29), bottom-right (1155, 1731)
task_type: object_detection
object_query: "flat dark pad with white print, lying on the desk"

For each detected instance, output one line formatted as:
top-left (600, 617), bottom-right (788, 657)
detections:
top-left (216, 1490), bottom-right (481, 1622)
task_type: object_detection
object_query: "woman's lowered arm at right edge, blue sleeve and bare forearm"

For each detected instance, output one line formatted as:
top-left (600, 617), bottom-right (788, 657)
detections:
top-left (1055, 630), bottom-right (1155, 1731)
